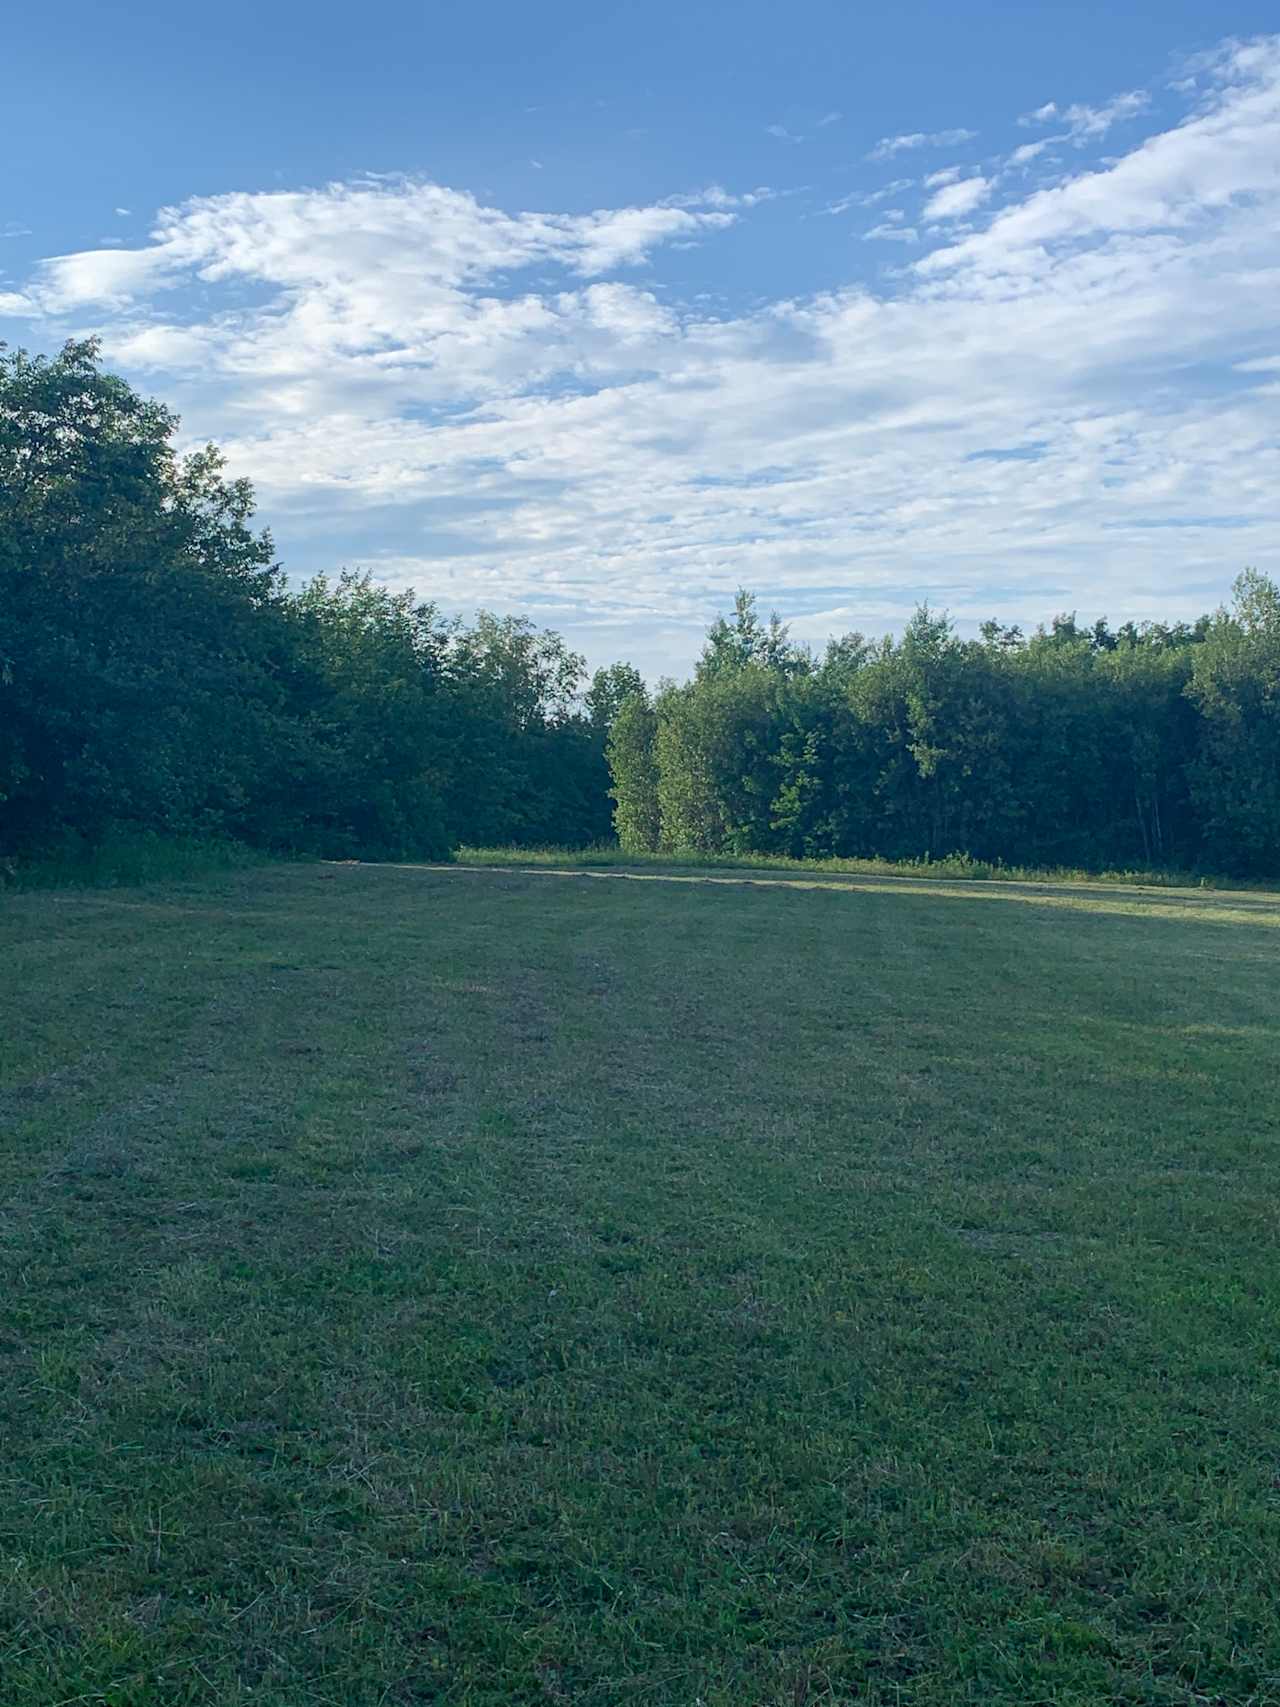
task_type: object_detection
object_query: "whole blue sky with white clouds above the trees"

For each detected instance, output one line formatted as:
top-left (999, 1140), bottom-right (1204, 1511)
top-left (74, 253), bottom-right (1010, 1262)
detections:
top-left (0, 0), bottom-right (1280, 679)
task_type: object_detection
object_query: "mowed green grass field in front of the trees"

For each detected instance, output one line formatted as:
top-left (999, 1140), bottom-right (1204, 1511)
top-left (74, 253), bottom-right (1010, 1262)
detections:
top-left (0, 865), bottom-right (1280, 1707)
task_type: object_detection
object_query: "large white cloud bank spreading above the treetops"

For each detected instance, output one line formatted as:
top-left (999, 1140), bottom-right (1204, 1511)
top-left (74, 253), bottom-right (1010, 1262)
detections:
top-left (10, 39), bottom-right (1280, 671)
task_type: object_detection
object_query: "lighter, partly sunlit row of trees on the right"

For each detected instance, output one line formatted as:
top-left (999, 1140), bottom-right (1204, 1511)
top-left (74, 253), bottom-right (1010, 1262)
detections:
top-left (609, 575), bottom-right (1280, 877)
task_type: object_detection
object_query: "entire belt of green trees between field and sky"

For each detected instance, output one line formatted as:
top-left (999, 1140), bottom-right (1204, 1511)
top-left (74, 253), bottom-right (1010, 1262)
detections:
top-left (0, 341), bottom-right (1280, 877)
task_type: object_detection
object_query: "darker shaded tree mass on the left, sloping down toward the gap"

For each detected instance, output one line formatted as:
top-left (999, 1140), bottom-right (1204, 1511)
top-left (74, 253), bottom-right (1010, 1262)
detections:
top-left (0, 341), bottom-right (621, 871)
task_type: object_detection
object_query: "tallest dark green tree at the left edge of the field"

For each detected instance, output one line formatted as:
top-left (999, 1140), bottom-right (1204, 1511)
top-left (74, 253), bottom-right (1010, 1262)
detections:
top-left (0, 341), bottom-right (287, 852)
